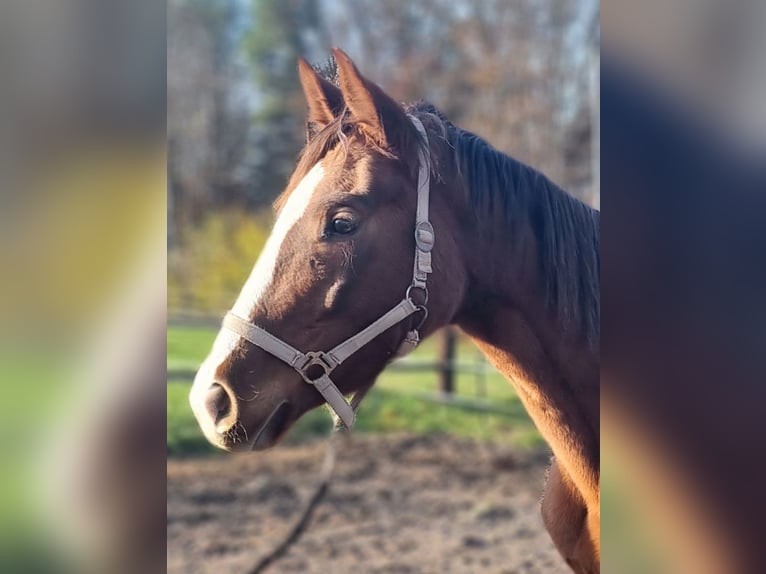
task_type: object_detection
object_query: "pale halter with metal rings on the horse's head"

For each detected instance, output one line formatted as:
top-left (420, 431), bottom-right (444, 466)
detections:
top-left (223, 116), bottom-right (435, 429)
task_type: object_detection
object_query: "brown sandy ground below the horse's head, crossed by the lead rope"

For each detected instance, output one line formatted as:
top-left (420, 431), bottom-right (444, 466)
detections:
top-left (167, 435), bottom-right (570, 574)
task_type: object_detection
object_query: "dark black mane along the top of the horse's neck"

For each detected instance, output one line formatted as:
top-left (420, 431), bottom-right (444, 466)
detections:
top-left (408, 102), bottom-right (600, 344)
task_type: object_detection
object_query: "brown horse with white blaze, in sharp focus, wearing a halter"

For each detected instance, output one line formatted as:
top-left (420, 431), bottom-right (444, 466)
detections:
top-left (190, 49), bottom-right (600, 574)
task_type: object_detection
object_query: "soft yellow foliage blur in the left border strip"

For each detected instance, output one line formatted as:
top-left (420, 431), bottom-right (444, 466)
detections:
top-left (0, 143), bottom-right (166, 338)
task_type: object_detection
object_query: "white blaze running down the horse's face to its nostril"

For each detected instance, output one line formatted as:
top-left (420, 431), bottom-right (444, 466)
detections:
top-left (189, 161), bottom-right (324, 433)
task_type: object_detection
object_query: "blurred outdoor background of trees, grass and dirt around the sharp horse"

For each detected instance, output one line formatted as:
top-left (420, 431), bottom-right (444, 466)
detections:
top-left (167, 0), bottom-right (599, 573)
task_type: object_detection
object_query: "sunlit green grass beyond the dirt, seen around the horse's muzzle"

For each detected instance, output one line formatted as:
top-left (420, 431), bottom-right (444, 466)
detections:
top-left (167, 327), bottom-right (544, 455)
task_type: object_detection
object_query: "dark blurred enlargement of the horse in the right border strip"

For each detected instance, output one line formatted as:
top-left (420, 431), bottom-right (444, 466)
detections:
top-left (601, 41), bottom-right (766, 573)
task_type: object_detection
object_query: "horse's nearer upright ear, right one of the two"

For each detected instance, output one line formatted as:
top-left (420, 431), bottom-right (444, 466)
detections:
top-left (332, 48), bottom-right (409, 149)
